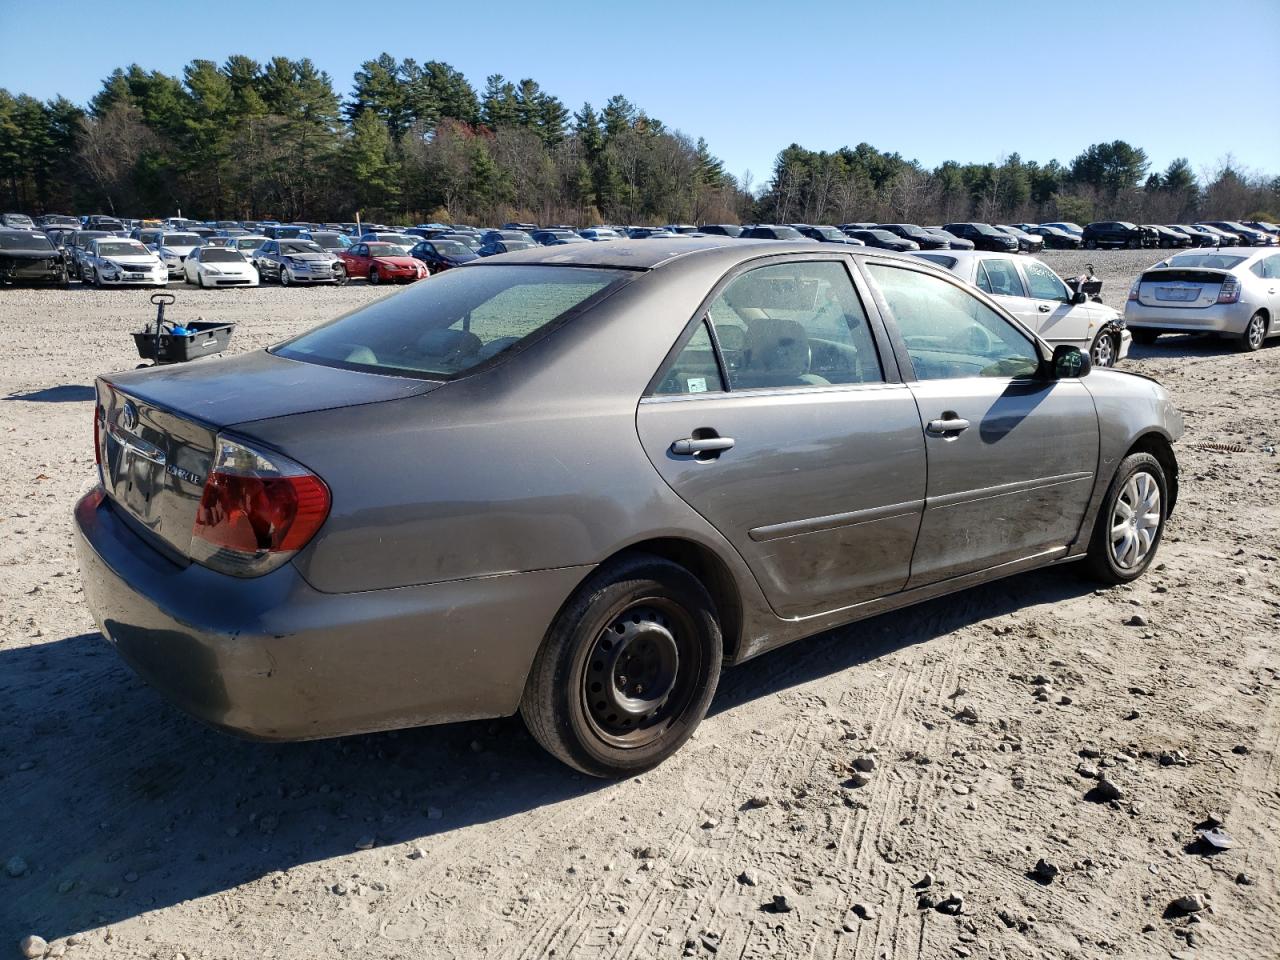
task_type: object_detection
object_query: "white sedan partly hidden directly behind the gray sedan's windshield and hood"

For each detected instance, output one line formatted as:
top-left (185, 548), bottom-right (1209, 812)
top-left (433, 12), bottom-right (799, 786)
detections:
top-left (915, 250), bottom-right (1133, 366)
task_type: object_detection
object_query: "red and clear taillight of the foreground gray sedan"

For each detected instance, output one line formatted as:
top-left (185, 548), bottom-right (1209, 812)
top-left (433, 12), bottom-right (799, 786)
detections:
top-left (191, 436), bottom-right (329, 576)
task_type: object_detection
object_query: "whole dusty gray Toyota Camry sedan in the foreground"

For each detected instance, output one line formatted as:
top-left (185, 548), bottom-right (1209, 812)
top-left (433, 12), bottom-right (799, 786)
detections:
top-left (76, 237), bottom-right (1183, 777)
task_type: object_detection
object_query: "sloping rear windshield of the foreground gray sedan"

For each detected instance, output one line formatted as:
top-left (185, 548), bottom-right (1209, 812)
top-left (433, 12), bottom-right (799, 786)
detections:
top-left (274, 266), bottom-right (628, 380)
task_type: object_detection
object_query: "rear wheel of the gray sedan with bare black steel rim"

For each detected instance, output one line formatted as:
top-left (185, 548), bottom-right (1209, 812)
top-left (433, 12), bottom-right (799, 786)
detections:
top-left (520, 554), bottom-right (723, 778)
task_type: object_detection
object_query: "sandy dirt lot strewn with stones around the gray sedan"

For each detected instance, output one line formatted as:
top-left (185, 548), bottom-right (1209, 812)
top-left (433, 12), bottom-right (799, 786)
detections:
top-left (0, 252), bottom-right (1280, 960)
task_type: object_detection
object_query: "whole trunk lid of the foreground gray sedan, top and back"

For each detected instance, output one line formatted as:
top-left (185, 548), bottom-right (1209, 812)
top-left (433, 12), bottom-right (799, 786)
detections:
top-left (96, 351), bottom-right (440, 558)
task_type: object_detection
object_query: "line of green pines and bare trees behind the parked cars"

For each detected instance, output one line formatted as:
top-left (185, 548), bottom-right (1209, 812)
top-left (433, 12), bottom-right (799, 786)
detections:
top-left (0, 54), bottom-right (1280, 224)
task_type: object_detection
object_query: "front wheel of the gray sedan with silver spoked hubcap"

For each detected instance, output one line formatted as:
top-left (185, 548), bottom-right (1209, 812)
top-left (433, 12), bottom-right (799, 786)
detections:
top-left (1085, 453), bottom-right (1169, 585)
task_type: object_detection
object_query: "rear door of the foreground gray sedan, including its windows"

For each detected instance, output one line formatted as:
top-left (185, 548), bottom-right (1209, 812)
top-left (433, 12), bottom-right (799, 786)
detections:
top-left (636, 255), bottom-right (925, 618)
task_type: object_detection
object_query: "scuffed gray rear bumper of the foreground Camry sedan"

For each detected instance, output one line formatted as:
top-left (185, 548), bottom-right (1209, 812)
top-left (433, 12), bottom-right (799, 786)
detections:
top-left (76, 488), bottom-right (590, 740)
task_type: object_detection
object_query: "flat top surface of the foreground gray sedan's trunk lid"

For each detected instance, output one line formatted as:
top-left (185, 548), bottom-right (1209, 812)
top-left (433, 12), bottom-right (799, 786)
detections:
top-left (106, 349), bottom-right (442, 428)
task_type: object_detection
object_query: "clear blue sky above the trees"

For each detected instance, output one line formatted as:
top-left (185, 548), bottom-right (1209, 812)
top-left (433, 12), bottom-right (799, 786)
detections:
top-left (0, 0), bottom-right (1280, 187)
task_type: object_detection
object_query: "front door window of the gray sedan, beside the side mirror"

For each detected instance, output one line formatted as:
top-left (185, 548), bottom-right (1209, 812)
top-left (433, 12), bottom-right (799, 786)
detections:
top-left (867, 264), bottom-right (1039, 380)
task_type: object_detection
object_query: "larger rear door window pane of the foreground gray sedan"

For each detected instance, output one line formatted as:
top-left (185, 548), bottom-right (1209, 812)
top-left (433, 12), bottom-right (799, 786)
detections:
top-left (707, 260), bottom-right (884, 389)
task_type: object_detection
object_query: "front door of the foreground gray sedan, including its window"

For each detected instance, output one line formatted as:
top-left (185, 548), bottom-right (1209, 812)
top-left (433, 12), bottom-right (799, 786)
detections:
top-left (865, 262), bottom-right (1098, 588)
